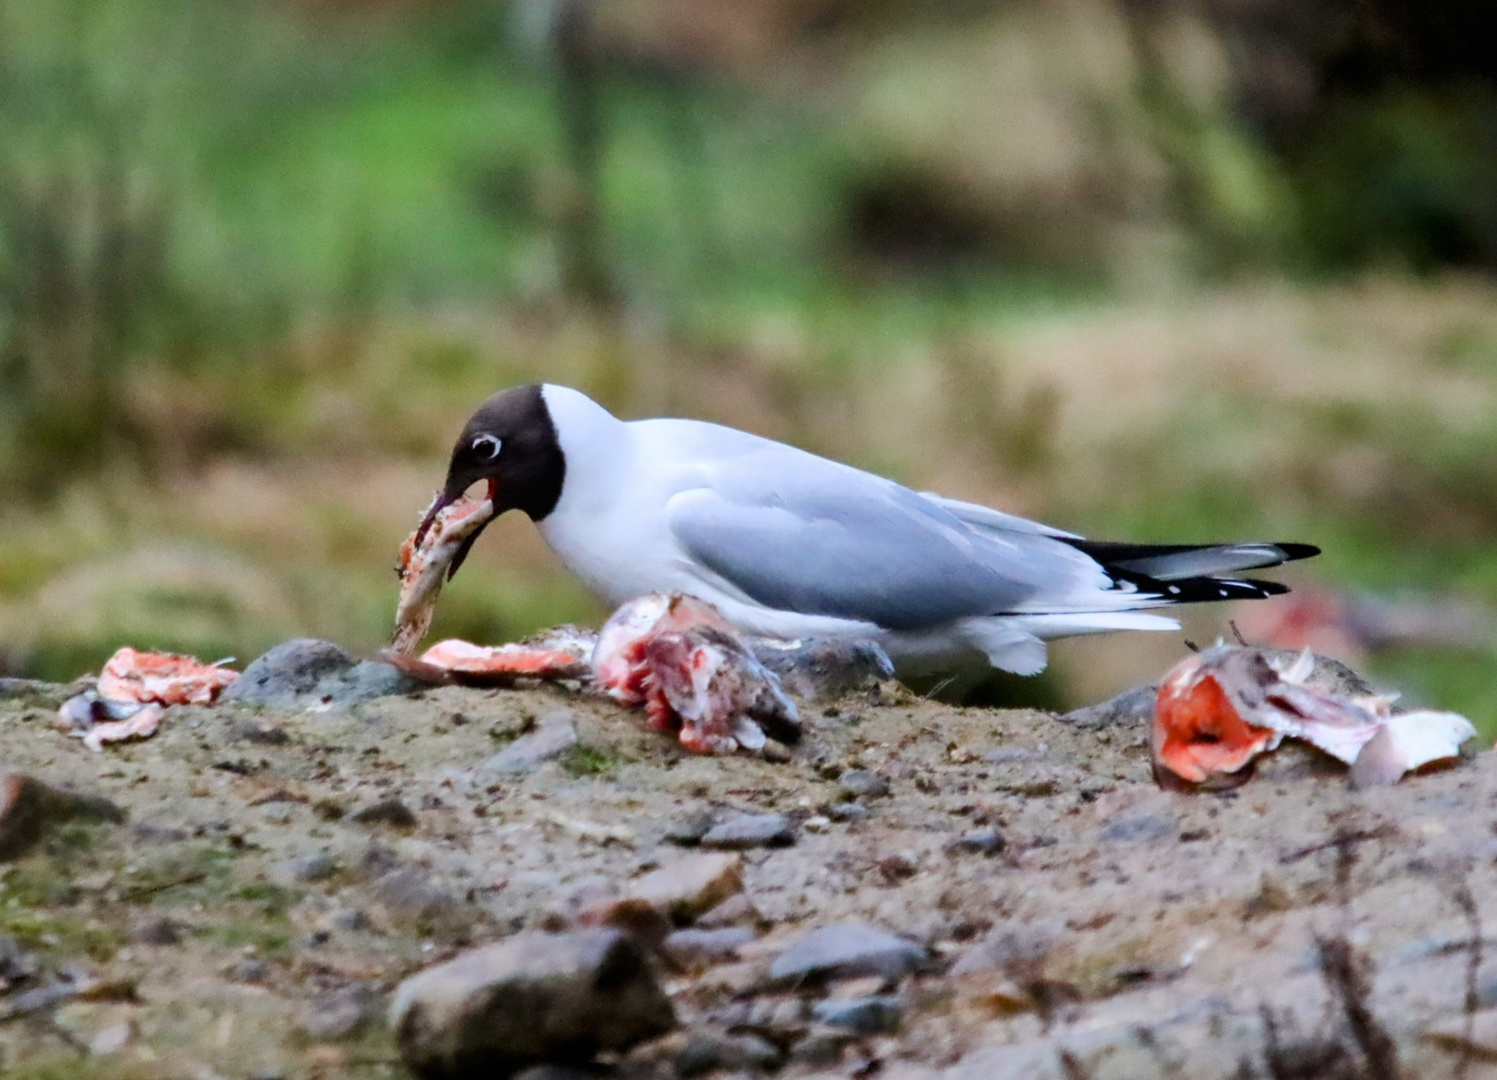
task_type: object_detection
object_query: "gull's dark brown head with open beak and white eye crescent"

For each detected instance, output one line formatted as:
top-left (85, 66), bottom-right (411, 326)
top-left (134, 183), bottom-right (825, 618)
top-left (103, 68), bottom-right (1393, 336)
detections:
top-left (416, 385), bottom-right (566, 578)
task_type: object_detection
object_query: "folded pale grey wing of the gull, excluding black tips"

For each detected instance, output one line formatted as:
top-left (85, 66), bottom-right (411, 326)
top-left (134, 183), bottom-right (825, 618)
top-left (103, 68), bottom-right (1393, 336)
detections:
top-left (666, 446), bottom-right (1112, 629)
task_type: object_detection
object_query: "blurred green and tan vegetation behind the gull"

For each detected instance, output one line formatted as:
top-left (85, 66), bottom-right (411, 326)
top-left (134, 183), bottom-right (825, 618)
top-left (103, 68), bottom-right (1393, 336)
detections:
top-left (0, 0), bottom-right (1497, 732)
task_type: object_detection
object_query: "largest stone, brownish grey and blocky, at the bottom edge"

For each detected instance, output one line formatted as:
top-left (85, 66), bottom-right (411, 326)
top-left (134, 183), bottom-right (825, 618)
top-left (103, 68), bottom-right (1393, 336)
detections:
top-left (391, 930), bottom-right (675, 1080)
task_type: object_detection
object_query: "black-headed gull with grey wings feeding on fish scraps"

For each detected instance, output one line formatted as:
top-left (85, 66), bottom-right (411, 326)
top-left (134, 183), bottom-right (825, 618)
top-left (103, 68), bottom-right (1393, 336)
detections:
top-left (427, 383), bottom-right (1319, 674)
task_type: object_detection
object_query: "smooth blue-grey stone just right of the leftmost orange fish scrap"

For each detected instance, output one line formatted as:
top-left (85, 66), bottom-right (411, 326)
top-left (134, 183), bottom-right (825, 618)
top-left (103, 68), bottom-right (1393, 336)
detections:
top-left (222, 638), bottom-right (425, 709)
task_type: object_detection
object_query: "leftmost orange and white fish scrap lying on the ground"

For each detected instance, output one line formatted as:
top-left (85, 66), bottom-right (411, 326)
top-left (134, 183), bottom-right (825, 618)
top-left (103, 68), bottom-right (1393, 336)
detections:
top-left (55, 646), bottom-right (240, 753)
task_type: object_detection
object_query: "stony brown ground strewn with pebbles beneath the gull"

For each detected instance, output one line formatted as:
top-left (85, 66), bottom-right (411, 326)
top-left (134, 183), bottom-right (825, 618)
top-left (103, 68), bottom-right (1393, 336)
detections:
top-left (0, 641), bottom-right (1497, 1080)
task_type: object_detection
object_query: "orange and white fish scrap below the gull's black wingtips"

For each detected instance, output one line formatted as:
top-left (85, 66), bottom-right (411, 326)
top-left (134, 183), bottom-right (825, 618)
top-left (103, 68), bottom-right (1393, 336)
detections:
top-left (1151, 644), bottom-right (1476, 791)
